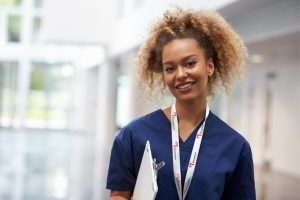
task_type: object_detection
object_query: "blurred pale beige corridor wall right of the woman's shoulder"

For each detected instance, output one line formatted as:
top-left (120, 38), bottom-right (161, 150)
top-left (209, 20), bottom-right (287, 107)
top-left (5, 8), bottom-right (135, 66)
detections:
top-left (241, 62), bottom-right (300, 177)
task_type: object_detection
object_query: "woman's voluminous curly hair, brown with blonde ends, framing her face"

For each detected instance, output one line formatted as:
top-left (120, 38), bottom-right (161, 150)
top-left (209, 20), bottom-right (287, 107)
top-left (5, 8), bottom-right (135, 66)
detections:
top-left (136, 7), bottom-right (247, 98)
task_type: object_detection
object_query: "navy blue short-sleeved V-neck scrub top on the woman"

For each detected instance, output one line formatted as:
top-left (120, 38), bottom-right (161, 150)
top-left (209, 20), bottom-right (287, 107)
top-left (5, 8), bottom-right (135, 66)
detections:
top-left (106, 109), bottom-right (255, 200)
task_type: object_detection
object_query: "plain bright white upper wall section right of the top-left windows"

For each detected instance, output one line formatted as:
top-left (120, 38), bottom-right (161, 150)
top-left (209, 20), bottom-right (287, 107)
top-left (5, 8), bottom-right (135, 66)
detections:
top-left (44, 0), bottom-right (118, 45)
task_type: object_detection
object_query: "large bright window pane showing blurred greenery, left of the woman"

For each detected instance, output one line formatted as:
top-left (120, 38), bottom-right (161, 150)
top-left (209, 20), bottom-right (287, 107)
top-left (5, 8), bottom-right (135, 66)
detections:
top-left (26, 63), bottom-right (74, 128)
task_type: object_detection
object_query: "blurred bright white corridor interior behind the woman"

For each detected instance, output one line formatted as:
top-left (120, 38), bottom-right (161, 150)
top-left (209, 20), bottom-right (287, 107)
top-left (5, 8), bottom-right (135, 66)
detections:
top-left (0, 0), bottom-right (300, 200)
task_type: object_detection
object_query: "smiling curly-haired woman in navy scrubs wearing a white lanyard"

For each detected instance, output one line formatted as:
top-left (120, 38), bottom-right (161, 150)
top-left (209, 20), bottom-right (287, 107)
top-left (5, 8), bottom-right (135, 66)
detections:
top-left (107, 8), bottom-right (255, 200)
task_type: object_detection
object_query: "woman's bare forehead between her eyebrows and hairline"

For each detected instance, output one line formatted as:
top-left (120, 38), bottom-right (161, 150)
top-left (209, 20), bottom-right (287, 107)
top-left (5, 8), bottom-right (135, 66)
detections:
top-left (162, 38), bottom-right (204, 62)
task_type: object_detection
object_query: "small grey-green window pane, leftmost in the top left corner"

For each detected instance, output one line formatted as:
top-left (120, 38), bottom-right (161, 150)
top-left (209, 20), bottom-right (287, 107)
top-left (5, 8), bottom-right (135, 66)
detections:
top-left (7, 16), bottom-right (21, 42)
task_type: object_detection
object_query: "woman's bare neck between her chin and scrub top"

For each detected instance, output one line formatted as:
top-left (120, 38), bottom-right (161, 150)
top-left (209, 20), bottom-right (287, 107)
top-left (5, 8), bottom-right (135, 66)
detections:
top-left (176, 98), bottom-right (207, 125)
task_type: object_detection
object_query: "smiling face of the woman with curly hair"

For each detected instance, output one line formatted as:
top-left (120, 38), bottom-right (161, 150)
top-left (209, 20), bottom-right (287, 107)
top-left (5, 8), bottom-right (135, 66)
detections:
top-left (162, 38), bottom-right (214, 101)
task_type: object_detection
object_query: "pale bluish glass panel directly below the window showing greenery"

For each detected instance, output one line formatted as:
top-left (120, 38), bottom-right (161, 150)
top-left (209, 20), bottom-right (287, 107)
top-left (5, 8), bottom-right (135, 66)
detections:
top-left (24, 130), bottom-right (72, 200)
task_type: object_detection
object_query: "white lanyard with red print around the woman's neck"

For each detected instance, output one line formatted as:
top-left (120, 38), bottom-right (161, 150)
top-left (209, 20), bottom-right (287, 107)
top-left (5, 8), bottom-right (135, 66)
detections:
top-left (171, 104), bottom-right (209, 200)
